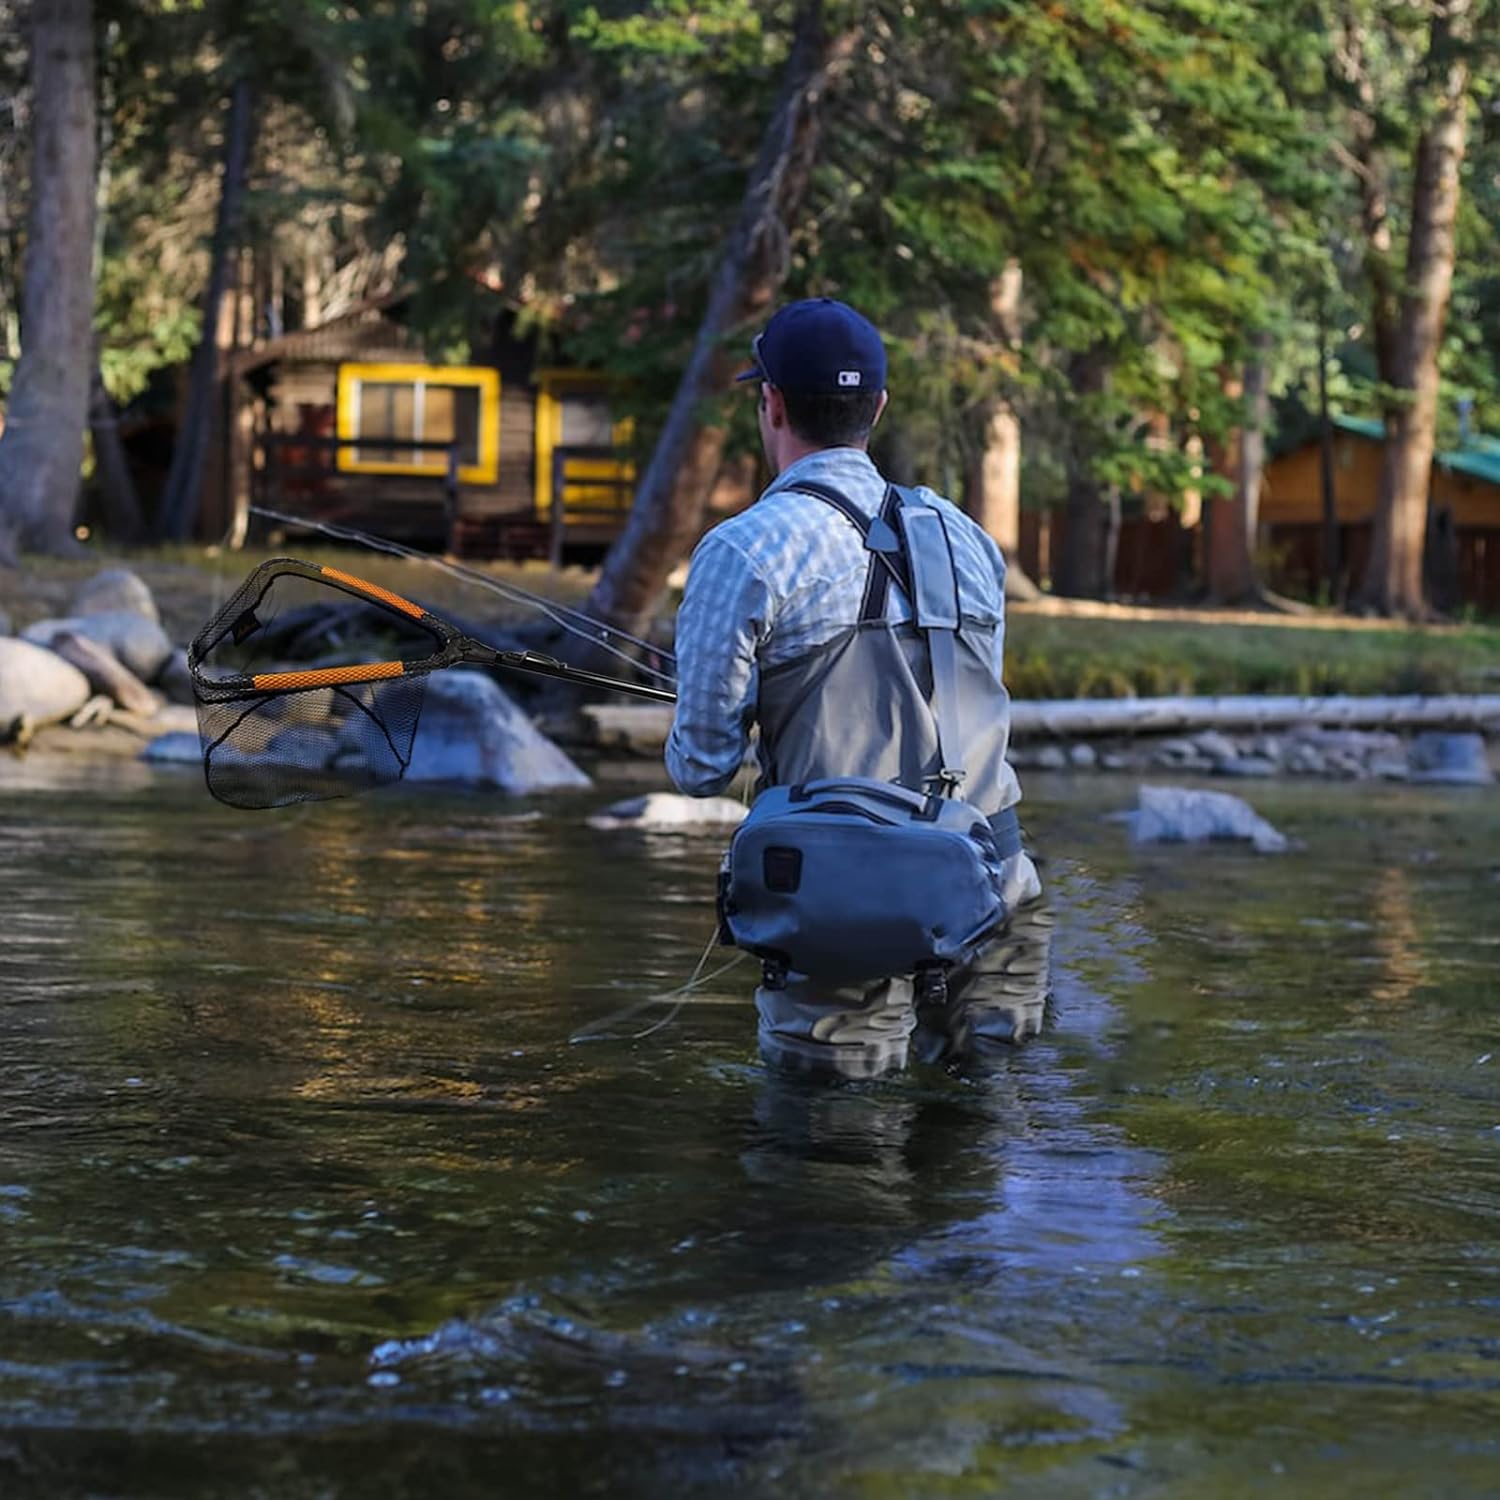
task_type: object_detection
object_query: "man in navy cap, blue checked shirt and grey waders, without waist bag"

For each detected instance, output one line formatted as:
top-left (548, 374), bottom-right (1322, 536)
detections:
top-left (666, 299), bottom-right (1050, 1074)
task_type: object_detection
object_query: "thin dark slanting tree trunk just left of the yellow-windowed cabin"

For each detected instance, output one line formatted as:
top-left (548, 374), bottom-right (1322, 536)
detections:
top-left (156, 78), bottom-right (255, 542)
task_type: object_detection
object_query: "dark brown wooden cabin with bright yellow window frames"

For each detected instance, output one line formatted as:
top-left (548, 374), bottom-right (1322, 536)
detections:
top-left (203, 299), bottom-right (636, 561)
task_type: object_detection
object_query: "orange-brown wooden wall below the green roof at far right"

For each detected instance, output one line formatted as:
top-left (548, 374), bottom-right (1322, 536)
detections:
top-left (1260, 432), bottom-right (1500, 528)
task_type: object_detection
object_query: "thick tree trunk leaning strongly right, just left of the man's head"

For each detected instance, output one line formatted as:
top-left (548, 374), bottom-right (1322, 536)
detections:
top-left (585, 0), bottom-right (834, 633)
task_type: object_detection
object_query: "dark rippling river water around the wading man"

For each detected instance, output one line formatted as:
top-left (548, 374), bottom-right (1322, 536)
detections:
top-left (0, 761), bottom-right (1500, 1500)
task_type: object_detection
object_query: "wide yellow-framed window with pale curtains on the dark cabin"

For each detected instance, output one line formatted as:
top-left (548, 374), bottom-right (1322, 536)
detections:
top-left (339, 365), bottom-right (500, 485)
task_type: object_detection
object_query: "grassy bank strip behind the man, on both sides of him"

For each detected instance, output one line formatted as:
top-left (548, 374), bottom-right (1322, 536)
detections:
top-left (0, 543), bottom-right (1500, 699)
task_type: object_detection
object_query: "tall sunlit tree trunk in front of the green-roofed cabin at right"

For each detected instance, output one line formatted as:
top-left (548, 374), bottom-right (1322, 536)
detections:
top-left (1361, 0), bottom-right (1470, 618)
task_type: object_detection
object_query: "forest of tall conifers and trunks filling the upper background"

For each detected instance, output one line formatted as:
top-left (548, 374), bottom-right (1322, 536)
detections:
top-left (0, 0), bottom-right (1500, 639)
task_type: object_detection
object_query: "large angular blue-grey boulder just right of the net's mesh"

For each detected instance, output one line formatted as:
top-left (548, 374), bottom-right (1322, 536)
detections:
top-left (407, 671), bottom-right (591, 797)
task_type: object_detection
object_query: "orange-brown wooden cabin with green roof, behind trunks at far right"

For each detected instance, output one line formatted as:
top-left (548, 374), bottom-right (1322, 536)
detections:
top-left (1260, 417), bottom-right (1500, 614)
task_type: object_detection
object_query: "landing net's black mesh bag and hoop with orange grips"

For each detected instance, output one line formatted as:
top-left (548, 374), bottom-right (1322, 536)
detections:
top-left (189, 560), bottom-right (449, 809)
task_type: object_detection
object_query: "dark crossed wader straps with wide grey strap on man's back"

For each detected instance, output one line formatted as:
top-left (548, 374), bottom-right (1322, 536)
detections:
top-left (788, 480), bottom-right (963, 797)
